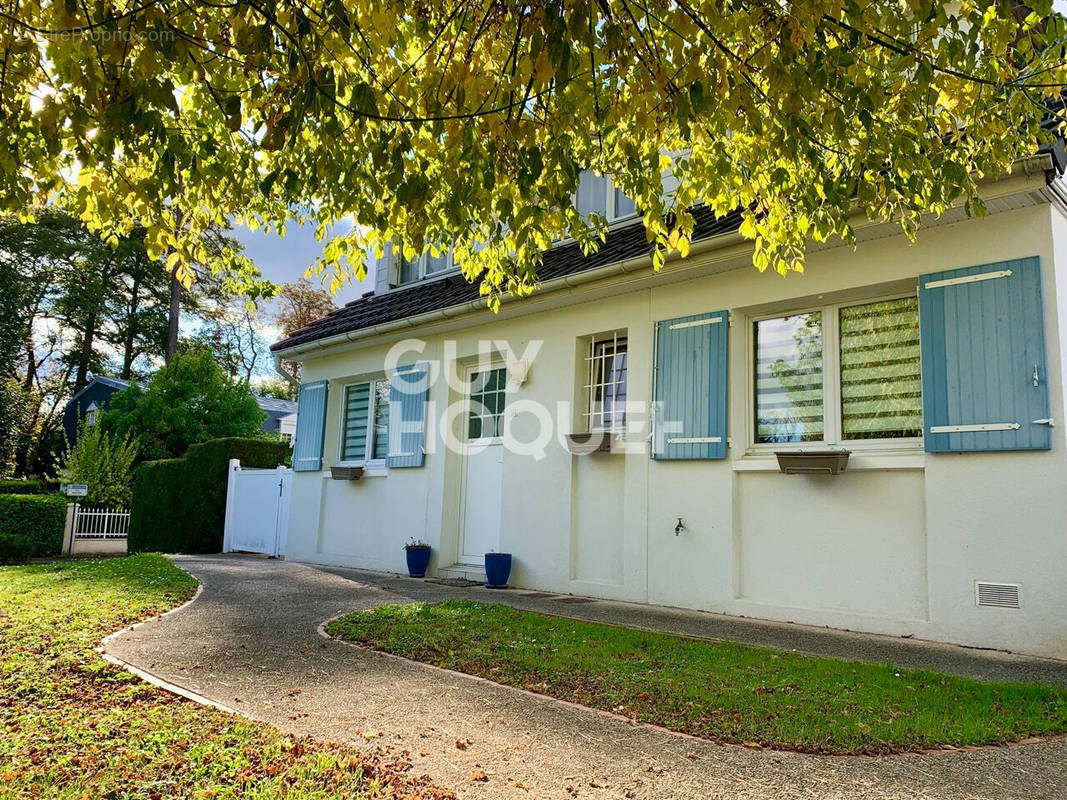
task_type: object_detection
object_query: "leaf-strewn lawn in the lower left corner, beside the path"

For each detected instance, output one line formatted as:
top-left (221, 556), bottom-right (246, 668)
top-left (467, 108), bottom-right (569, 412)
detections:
top-left (0, 556), bottom-right (451, 800)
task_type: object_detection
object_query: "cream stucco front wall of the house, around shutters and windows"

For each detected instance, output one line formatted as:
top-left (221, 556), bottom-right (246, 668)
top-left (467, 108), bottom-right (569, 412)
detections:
top-left (287, 197), bottom-right (1067, 657)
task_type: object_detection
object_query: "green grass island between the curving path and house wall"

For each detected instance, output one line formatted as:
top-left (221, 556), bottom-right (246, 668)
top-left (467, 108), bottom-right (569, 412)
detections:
top-left (328, 599), bottom-right (1067, 753)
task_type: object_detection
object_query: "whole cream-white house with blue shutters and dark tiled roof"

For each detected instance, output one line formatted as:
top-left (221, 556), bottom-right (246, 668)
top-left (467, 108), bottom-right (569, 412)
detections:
top-left (268, 154), bottom-right (1067, 657)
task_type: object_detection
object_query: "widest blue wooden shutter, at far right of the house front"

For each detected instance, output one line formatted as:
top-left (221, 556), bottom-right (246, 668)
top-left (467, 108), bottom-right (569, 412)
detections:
top-left (919, 256), bottom-right (1052, 452)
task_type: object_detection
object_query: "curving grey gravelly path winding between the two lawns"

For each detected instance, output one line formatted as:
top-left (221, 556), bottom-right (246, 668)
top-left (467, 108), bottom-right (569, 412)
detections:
top-left (107, 556), bottom-right (1067, 800)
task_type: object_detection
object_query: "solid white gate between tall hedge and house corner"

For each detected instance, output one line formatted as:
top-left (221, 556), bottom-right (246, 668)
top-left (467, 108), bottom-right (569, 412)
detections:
top-left (222, 459), bottom-right (292, 556)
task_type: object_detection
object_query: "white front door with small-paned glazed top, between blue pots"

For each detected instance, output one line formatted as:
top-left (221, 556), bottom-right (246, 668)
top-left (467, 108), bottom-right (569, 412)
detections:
top-left (459, 367), bottom-right (507, 566)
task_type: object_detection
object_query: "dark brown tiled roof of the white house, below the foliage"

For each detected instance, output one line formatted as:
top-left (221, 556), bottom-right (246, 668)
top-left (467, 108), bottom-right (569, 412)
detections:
top-left (271, 207), bottom-right (740, 351)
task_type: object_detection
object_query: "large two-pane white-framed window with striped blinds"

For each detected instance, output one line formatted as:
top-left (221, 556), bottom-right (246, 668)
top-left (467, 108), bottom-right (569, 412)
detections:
top-left (753, 294), bottom-right (922, 445)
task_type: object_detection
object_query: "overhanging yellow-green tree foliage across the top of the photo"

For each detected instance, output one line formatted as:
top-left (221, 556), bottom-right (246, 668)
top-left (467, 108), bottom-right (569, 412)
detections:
top-left (0, 0), bottom-right (1065, 300)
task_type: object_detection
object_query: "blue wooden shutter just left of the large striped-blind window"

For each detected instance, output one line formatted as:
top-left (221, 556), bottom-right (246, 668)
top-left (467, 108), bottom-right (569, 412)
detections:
top-left (652, 311), bottom-right (730, 460)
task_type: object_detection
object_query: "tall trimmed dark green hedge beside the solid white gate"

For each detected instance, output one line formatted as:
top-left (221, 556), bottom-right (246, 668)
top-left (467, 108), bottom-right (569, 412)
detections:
top-left (127, 438), bottom-right (289, 553)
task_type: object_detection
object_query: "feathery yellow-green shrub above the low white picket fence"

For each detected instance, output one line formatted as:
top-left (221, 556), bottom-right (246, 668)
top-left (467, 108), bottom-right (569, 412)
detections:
top-left (60, 420), bottom-right (138, 508)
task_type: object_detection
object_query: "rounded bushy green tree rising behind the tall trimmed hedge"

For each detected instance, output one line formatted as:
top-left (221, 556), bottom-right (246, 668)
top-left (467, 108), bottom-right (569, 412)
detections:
top-left (100, 350), bottom-right (267, 460)
